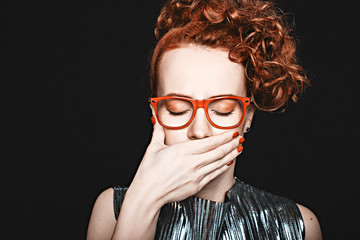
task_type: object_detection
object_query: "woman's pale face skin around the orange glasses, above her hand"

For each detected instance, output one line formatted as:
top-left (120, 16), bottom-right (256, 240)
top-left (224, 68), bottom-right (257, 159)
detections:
top-left (153, 45), bottom-right (254, 145)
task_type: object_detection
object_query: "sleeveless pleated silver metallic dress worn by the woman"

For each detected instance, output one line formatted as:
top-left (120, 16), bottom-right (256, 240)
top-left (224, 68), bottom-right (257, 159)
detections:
top-left (114, 177), bottom-right (305, 240)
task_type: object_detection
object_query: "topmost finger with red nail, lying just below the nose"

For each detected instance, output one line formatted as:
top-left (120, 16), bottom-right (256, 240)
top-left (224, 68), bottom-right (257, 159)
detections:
top-left (181, 131), bottom-right (238, 154)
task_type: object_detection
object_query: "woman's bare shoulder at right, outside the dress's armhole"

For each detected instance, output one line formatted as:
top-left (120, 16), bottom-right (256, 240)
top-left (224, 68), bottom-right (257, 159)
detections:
top-left (296, 204), bottom-right (322, 240)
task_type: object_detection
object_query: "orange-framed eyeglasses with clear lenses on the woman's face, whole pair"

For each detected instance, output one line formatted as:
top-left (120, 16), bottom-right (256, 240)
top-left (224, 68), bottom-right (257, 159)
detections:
top-left (149, 96), bottom-right (253, 129)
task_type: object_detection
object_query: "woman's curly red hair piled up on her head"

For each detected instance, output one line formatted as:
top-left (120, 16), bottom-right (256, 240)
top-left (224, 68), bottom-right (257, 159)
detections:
top-left (150, 0), bottom-right (309, 111)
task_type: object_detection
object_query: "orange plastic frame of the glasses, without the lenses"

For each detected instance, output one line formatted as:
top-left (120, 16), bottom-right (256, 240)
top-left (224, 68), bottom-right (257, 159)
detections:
top-left (149, 96), bottom-right (253, 129)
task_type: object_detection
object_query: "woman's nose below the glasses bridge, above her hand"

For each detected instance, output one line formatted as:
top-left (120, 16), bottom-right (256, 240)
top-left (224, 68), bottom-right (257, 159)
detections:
top-left (187, 108), bottom-right (213, 140)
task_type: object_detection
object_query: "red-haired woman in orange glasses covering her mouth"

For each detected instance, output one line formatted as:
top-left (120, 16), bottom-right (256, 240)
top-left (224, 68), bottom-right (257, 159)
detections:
top-left (87, 0), bottom-right (321, 239)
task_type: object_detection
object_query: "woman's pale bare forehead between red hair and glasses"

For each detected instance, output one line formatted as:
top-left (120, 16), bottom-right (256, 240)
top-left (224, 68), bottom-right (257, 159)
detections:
top-left (158, 45), bottom-right (246, 99)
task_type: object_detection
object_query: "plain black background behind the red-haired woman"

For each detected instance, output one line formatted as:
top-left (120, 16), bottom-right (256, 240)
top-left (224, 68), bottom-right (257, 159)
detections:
top-left (0, 0), bottom-right (360, 239)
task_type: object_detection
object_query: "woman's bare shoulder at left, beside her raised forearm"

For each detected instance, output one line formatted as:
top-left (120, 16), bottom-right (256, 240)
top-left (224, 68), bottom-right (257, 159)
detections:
top-left (87, 188), bottom-right (116, 240)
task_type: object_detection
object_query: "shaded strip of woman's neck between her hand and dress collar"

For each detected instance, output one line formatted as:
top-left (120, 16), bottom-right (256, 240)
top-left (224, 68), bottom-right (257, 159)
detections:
top-left (195, 165), bottom-right (235, 202)
